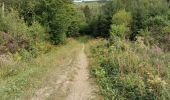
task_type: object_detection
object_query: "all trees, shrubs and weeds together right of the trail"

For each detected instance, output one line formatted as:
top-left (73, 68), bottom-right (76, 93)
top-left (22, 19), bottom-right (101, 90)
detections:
top-left (89, 0), bottom-right (170, 100)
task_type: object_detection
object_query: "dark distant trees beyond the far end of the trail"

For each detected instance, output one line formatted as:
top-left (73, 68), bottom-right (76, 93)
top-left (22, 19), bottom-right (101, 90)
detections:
top-left (77, 2), bottom-right (108, 37)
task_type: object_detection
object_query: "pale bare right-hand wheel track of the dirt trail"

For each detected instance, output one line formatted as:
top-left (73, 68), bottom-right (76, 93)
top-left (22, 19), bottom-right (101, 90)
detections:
top-left (67, 45), bottom-right (92, 100)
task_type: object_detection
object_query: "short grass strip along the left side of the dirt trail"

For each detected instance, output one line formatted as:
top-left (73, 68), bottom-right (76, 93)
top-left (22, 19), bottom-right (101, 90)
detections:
top-left (0, 40), bottom-right (80, 100)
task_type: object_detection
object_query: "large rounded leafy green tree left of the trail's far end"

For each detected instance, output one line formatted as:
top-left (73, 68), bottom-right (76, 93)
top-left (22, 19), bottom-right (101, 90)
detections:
top-left (43, 0), bottom-right (79, 44)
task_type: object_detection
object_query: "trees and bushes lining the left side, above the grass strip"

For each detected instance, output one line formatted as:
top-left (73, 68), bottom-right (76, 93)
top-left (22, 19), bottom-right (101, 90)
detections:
top-left (0, 0), bottom-right (83, 58)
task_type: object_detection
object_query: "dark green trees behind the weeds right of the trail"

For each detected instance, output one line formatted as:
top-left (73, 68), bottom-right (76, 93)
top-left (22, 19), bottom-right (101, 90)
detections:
top-left (86, 0), bottom-right (170, 49)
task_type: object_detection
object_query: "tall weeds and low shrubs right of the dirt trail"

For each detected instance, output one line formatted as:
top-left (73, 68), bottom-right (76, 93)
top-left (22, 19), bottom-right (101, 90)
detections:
top-left (91, 39), bottom-right (170, 100)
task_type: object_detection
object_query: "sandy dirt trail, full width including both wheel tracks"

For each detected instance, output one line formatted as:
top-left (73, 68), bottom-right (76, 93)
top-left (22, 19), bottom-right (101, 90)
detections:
top-left (29, 44), bottom-right (97, 100)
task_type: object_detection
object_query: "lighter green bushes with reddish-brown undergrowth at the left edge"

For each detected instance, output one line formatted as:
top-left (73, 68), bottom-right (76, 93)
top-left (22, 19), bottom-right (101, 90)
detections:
top-left (0, 11), bottom-right (48, 59)
